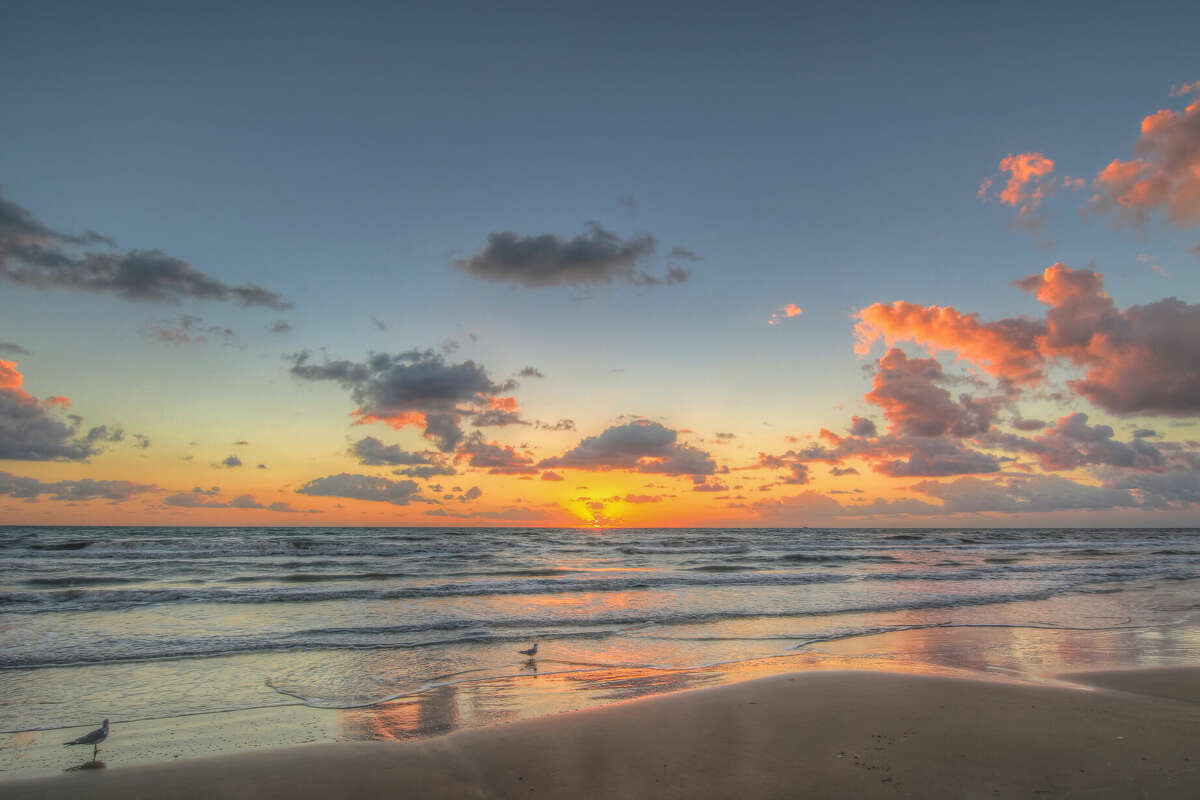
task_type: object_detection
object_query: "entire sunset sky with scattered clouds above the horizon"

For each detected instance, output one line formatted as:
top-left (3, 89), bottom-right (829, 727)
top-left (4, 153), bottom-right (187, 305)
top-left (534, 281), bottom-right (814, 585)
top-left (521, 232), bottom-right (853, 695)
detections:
top-left (0, 2), bottom-right (1200, 528)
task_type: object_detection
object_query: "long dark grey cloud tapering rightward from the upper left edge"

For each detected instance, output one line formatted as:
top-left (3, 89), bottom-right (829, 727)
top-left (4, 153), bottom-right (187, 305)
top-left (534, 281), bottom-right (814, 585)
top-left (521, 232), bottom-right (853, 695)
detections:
top-left (0, 189), bottom-right (292, 309)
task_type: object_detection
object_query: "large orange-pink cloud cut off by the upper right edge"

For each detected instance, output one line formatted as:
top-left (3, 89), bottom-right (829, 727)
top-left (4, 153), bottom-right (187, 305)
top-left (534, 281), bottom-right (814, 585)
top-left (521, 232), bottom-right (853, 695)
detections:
top-left (1088, 84), bottom-right (1200, 237)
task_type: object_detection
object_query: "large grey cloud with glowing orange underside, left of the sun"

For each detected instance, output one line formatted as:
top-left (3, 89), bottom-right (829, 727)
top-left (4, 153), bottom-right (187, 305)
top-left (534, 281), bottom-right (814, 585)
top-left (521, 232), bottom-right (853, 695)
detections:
top-left (289, 350), bottom-right (517, 452)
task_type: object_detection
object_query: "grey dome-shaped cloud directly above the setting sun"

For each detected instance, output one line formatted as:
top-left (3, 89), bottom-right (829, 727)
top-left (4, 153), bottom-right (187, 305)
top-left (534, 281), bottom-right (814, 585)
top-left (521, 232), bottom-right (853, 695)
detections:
top-left (538, 420), bottom-right (716, 476)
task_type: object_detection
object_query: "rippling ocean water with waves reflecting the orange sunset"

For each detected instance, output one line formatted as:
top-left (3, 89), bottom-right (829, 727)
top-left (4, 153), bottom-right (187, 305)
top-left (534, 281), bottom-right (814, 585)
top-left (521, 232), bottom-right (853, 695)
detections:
top-left (0, 527), bottom-right (1200, 762)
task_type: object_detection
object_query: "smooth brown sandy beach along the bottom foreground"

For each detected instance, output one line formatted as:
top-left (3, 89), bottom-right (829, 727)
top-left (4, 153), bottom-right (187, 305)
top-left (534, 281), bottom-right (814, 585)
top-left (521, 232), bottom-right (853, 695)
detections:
top-left (0, 668), bottom-right (1200, 800)
